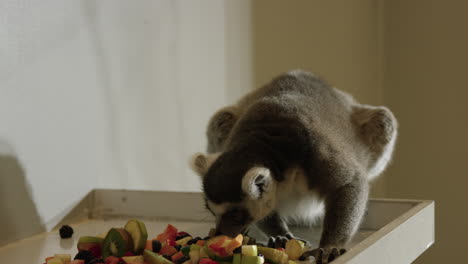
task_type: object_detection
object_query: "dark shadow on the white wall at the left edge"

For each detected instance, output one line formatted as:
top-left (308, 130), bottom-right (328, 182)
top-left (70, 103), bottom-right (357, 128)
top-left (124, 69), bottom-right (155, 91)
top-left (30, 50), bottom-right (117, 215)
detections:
top-left (0, 139), bottom-right (45, 246)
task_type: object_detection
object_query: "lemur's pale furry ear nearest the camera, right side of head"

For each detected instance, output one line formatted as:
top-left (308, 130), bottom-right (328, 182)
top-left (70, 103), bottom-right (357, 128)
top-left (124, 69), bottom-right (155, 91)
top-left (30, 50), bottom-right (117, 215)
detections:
top-left (242, 167), bottom-right (273, 200)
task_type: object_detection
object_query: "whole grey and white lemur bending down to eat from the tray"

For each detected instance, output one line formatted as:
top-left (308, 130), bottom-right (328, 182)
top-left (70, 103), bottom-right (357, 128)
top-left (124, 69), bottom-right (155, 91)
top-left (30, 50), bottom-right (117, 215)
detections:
top-left (192, 71), bottom-right (397, 263)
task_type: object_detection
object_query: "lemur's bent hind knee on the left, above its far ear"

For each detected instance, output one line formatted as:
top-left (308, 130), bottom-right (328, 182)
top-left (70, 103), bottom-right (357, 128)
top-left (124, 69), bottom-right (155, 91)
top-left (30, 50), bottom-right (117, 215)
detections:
top-left (206, 106), bottom-right (239, 153)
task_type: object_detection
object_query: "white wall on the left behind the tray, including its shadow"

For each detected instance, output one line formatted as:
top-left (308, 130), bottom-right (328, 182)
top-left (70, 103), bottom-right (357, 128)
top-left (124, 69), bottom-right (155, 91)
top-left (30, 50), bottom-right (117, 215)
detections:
top-left (0, 0), bottom-right (252, 241)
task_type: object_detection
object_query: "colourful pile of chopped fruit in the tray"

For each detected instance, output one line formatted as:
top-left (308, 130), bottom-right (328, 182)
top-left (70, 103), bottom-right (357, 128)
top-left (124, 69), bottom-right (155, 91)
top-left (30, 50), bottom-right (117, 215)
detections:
top-left (45, 220), bottom-right (305, 264)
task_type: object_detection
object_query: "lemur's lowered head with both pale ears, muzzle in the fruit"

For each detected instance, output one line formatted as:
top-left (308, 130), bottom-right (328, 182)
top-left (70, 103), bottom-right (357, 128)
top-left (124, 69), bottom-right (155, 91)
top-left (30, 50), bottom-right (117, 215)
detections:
top-left (191, 153), bottom-right (276, 236)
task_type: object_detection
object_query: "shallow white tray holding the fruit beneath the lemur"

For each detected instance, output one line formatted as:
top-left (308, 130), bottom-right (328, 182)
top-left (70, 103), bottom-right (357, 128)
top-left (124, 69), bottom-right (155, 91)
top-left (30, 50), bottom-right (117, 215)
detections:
top-left (0, 190), bottom-right (434, 264)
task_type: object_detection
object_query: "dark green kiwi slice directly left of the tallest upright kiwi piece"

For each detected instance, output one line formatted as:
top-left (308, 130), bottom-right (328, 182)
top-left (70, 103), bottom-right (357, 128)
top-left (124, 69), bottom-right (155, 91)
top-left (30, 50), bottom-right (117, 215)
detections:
top-left (102, 228), bottom-right (132, 259)
